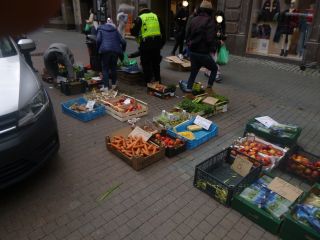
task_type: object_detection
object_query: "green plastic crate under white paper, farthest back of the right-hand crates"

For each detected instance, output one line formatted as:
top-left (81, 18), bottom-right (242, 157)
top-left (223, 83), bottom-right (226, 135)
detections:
top-left (244, 118), bottom-right (302, 148)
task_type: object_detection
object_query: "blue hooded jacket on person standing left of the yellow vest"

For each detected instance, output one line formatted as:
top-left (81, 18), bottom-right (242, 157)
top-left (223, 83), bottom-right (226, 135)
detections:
top-left (97, 23), bottom-right (126, 55)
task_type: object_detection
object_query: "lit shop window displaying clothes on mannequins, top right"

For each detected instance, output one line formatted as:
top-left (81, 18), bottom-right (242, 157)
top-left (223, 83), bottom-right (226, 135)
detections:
top-left (247, 0), bottom-right (315, 60)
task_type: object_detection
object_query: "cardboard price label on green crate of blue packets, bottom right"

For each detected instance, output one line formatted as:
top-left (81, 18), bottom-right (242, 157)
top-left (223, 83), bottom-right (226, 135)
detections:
top-left (268, 177), bottom-right (303, 202)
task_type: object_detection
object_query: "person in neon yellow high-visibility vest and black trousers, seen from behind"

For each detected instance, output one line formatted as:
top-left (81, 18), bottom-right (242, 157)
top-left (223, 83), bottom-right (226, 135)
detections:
top-left (130, 4), bottom-right (166, 84)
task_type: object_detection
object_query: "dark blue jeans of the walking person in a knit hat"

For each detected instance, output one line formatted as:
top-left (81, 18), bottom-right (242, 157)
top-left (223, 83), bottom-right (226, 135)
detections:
top-left (187, 52), bottom-right (218, 89)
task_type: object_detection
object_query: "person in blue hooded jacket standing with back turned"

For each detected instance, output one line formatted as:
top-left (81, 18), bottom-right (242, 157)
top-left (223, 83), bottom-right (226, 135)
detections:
top-left (97, 19), bottom-right (127, 91)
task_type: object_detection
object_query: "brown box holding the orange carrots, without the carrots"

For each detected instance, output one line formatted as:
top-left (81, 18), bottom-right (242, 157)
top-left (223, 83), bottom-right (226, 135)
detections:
top-left (106, 127), bottom-right (165, 171)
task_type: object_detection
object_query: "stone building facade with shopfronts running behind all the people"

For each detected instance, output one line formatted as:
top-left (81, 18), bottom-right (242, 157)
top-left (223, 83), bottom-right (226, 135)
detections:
top-left (56, 0), bottom-right (320, 62)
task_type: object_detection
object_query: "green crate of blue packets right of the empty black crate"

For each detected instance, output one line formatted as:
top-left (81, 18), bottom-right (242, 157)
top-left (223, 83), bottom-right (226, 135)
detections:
top-left (231, 174), bottom-right (293, 234)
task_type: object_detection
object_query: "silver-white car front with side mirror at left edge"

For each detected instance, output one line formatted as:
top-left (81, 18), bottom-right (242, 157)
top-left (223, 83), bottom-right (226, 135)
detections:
top-left (0, 37), bottom-right (59, 189)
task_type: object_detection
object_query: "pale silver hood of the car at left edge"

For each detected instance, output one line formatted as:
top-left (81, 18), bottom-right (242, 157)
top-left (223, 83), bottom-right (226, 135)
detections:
top-left (0, 55), bottom-right (40, 116)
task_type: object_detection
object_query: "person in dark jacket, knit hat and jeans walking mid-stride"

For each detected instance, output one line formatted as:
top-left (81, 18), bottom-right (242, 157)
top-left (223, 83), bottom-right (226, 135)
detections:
top-left (184, 0), bottom-right (218, 93)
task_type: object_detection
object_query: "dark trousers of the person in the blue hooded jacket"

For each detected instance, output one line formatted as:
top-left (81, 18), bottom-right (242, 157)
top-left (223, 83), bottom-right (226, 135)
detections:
top-left (101, 52), bottom-right (118, 88)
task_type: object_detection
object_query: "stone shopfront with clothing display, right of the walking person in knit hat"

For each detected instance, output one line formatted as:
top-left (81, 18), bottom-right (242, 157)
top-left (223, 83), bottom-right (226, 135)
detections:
top-left (222, 0), bottom-right (320, 62)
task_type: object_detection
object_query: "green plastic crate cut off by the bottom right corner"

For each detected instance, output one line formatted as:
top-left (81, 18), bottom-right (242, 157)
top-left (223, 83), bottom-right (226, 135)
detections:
top-left (279, 184), bottom-right (320, 240)
